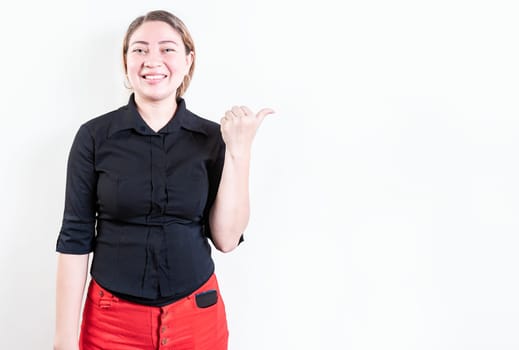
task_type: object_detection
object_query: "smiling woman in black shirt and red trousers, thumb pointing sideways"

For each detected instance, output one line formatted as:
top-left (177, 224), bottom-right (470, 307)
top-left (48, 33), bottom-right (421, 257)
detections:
top-left (54, 11), bottom-right (273, 350)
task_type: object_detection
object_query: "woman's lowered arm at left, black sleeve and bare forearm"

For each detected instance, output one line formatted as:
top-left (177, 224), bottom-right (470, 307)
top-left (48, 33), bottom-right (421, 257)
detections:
top-left (54, 127), bottom-right (97, 350)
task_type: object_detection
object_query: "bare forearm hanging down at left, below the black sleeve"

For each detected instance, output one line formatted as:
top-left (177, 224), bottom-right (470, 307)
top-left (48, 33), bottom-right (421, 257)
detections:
top-left (54, 254), bottom-right (89, 349)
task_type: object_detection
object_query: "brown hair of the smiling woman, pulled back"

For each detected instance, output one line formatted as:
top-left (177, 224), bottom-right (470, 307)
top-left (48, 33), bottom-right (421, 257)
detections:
top-left (123, 10), bottom-right (195, 98)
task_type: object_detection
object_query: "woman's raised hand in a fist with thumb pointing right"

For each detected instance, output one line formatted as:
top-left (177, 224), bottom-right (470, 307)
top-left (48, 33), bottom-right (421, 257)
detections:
top-left (220, 106), bottom-right (274, 157)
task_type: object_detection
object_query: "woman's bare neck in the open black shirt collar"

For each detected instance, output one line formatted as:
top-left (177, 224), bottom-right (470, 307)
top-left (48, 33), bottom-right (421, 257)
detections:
top-left (135, 95), bottom-right (177, 132)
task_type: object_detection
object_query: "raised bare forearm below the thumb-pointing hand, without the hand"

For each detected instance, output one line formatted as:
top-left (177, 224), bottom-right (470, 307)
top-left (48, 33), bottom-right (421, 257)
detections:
top-left (209, 151), bottom-right (250, 252)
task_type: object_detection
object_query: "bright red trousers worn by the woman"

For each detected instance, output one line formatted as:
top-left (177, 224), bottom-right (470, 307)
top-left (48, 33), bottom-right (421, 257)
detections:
top-left (79, 274), bottom-right (228, 350)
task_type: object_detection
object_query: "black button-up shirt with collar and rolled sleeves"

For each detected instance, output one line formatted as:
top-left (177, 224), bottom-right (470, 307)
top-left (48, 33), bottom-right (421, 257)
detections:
top-left (56, 95), bottom-right (230, 303)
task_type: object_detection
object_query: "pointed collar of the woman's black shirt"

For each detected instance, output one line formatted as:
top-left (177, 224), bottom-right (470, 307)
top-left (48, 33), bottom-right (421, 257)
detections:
top-left (108, 94), bottom-right (208, 137)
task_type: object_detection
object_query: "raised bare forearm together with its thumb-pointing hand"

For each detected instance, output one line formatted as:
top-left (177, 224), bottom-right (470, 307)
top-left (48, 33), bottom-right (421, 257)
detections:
top-left (209, 106), bottom-right (274, 252)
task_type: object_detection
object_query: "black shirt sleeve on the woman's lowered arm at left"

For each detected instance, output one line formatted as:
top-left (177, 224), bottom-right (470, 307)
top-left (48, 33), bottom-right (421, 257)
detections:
top-left (56, 125), bottom-right (97, 254)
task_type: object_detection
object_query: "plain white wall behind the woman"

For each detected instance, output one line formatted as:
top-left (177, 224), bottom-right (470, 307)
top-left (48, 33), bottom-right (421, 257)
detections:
top-left (0, 0), bottom-right (519, 350)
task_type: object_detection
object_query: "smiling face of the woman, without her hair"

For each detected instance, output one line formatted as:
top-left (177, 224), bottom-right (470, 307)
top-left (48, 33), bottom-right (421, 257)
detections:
top-left (126, 21), bottom-right (193, 102)
